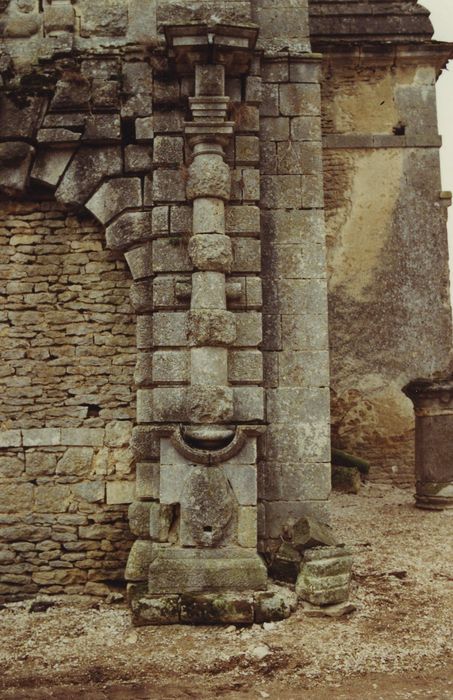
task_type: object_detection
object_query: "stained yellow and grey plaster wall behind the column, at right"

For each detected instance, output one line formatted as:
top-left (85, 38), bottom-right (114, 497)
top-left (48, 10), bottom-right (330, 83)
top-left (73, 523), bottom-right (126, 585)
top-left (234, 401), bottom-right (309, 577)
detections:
top-left (323, 66), bottom-right (451, 484)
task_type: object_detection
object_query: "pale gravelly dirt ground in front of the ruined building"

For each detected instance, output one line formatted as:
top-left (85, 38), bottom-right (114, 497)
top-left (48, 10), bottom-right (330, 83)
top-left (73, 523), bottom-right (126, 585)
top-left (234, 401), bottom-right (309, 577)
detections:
top-left (0, 484), bottom-right (453, 700)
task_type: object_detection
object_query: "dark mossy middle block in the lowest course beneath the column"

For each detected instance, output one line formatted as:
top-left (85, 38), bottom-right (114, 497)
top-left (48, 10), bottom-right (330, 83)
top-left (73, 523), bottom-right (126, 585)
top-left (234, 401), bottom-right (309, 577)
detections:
top-left (181, 593), bottom-right (254, 625)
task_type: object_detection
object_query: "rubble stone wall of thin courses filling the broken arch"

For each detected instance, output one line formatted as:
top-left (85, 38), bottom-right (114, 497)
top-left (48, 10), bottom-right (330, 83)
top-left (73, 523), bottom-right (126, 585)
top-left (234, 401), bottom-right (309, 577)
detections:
top-left (0, 201), bottom-right (135, 600)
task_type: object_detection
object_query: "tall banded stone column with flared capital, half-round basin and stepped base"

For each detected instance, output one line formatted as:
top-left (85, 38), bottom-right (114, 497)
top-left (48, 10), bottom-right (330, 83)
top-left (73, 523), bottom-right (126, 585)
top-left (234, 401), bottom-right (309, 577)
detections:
top-left (126, 25), bottom-right (293, 624)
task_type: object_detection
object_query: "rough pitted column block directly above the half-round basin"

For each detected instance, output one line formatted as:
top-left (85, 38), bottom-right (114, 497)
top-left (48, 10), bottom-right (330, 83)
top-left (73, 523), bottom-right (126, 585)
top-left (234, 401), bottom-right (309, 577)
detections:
top-left (186, 384), bottom-right (233, 423)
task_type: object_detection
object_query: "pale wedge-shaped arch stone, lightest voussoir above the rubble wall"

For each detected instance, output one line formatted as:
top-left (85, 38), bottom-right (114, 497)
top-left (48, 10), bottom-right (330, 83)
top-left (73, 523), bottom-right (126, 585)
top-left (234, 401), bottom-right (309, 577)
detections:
top-left (85, 177), bottom-right (142, 225)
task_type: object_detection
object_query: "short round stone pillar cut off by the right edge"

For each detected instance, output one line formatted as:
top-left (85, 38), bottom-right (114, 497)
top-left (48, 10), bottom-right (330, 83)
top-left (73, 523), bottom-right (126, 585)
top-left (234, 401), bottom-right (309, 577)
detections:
top-left (403, 378), bottom-right (453, 510)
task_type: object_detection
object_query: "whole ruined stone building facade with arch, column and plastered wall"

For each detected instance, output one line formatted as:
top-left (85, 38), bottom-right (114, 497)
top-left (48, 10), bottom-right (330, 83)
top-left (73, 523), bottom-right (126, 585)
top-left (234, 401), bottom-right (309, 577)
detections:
top-left (0, 0), bottom-right (451, 619)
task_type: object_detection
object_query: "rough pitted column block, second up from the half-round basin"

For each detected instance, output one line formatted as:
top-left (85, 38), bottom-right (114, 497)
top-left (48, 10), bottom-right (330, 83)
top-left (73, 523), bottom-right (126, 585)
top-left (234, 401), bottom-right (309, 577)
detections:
top-left (187, 309), bottom-right (236, 345)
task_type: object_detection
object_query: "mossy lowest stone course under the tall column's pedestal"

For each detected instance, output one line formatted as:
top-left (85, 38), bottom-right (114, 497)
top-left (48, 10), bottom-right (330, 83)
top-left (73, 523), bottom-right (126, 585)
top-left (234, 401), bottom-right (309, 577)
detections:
top-left (128, 584), bottom-right (297, 626)
